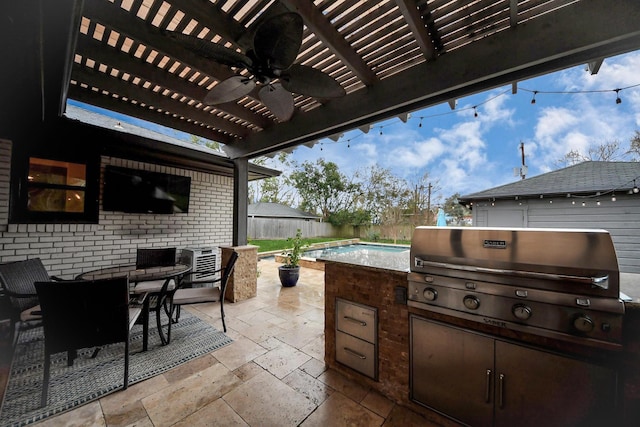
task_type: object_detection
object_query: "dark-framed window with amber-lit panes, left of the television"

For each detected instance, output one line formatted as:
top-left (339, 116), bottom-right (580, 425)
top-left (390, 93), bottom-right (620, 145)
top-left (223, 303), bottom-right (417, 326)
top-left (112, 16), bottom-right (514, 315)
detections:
top-left (10, 156), bottom-right (99, 223)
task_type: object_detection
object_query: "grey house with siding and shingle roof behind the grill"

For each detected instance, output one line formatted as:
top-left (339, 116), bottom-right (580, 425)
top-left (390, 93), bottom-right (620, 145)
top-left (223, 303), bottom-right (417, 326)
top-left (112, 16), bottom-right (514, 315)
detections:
top-left (459, 162), bottom-right (640, 273)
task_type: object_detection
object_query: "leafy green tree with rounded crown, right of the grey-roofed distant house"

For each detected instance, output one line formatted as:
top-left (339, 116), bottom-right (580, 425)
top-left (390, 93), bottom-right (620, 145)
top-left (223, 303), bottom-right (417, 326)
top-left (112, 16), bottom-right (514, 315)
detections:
top-left (290, 158), bottom-right (360, 220)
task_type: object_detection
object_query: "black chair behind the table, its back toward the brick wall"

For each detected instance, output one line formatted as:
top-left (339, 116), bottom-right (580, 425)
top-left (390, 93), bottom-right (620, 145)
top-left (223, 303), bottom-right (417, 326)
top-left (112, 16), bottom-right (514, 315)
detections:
top-left (135, 247), bottom-right (176, 345)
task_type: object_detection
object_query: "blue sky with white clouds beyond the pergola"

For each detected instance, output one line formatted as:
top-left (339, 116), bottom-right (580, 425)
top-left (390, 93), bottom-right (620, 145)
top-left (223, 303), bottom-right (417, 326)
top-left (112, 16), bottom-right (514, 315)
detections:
top-left (70, 51), bottom-right (640, 203)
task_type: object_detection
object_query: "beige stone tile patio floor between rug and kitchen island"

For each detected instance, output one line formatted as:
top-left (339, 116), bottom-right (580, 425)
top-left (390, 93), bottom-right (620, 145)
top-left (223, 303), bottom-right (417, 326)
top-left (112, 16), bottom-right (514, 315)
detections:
top-left (30, 260), bottom-right (440, 427)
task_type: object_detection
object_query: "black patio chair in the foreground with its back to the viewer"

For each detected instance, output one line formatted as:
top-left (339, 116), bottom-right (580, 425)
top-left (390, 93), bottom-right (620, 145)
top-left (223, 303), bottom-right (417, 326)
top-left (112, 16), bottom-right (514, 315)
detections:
top-left (35, 277), bottom-right (141, 407)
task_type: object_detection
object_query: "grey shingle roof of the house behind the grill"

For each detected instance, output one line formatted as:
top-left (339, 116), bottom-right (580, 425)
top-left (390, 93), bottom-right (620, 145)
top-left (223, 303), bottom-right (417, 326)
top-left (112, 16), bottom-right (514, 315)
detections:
top-left (460, 162), bottom-right (640, 200)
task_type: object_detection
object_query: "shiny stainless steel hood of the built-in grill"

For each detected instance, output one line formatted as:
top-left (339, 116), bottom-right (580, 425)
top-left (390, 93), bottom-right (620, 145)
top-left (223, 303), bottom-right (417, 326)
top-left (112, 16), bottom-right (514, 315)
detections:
top-left (410, 227), bottom-right (620, 298)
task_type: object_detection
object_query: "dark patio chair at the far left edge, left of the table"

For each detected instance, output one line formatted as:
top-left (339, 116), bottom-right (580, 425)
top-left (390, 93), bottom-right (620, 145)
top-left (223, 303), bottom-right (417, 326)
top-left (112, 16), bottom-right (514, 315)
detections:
top-left (0, 258), bottom-right (61, 346)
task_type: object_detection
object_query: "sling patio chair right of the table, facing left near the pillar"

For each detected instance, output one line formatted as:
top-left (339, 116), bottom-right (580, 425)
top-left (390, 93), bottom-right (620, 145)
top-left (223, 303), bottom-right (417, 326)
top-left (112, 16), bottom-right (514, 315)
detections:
top-left (170, 251), bottom-right (238, 332)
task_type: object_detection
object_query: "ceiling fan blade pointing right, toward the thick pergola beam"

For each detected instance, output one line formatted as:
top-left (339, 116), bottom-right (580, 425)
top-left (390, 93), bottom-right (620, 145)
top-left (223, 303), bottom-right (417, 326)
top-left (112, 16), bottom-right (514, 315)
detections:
top-left (280, 64), bottom-right (347, 98)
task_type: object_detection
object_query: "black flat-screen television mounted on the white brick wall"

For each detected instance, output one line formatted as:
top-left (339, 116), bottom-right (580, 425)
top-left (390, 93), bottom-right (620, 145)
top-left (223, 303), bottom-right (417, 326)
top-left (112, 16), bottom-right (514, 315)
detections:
top-left (102, 166), bottom-right (191, 214)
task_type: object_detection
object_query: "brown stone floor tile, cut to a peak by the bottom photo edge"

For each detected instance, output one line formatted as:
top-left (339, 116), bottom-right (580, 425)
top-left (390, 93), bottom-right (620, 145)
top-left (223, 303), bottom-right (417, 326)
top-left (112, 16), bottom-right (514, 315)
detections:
top-left (301, 393), bottom-right (384, 427)
